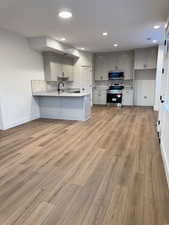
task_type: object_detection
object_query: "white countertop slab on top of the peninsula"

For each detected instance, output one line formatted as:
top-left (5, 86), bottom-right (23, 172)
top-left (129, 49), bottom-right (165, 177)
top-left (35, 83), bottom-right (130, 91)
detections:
top-left (32, 91), bottom-right (89, 97)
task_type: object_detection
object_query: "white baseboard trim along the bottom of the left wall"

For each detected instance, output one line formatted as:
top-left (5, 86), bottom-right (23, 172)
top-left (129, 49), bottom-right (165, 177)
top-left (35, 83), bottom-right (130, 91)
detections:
top-left (3, 113), bottom-right (40, 130)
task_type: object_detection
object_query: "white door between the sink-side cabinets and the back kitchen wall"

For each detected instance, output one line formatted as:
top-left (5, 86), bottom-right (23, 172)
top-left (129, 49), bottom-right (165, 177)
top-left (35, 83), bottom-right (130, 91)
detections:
top-left (80, 66), bottom-right (92, 105)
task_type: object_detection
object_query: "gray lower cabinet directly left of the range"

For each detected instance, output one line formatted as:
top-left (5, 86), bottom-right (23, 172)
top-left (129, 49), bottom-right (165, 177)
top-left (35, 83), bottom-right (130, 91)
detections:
top-left (93, 89), bottom-right (107, 105)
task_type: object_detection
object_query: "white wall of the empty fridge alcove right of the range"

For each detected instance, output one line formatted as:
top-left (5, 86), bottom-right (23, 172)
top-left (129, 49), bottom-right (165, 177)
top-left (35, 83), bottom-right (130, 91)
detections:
top-left (134, 70), bottom-right (155, 106)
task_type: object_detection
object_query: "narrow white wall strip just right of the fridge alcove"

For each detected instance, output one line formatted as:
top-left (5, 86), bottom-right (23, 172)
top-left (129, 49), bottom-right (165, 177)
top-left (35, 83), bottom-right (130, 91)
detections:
top-left (154, 45), bottom-right (164, 111)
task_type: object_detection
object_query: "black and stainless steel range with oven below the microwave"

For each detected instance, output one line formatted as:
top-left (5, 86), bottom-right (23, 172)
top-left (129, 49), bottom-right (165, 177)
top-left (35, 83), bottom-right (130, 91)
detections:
top-left (107, 84), bottom-right (124, 106)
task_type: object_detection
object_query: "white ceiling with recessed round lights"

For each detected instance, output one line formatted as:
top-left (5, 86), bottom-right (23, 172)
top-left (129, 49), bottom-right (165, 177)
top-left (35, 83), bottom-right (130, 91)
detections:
top-left (0, 0), bottom-right (169, 52)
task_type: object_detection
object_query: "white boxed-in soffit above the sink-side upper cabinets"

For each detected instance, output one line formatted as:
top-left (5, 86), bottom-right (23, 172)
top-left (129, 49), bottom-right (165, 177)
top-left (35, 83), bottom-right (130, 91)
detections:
top-left (28, 37), bottom-right (79, 58)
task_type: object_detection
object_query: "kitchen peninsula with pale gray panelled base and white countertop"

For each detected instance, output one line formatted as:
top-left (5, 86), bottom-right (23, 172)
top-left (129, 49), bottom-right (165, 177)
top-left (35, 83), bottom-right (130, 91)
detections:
top-left (32, 91), bottom-right (91, 121)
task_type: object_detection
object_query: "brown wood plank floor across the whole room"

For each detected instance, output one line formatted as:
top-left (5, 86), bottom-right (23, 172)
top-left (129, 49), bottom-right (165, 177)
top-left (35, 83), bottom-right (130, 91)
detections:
top-left (0, 107), bottom-right (169, 225)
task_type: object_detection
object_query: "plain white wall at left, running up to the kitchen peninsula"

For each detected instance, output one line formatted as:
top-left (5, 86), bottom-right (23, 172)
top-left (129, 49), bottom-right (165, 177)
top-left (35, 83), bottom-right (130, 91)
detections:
top-left (0, 30), bottom-right (44, 129)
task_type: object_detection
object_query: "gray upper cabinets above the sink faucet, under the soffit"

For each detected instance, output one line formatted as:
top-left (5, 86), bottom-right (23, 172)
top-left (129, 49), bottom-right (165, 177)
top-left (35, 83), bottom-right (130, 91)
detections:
top-left (43, 52), bottom-right (73, 81)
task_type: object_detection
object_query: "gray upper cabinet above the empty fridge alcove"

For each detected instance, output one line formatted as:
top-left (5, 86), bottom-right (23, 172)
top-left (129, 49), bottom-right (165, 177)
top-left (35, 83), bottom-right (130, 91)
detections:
top-left (134, 47), bottom-right (157, 70)
